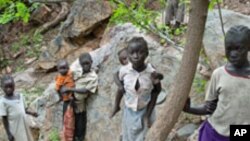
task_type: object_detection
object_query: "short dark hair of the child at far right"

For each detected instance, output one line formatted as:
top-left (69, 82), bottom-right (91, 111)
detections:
top-left (225, 25), bottom-right (250, 49)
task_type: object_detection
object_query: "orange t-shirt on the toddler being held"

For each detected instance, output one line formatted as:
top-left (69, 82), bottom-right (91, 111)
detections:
top-left (56, 70), bottom-right (75, 101)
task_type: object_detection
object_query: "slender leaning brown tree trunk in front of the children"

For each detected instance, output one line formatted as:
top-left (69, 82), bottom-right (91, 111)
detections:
top-left (146, 0), bottom-right (209, 141)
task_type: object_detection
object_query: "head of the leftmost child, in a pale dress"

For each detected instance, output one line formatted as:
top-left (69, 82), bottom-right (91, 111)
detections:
top-left (1, 75), bottom-right (15, 96)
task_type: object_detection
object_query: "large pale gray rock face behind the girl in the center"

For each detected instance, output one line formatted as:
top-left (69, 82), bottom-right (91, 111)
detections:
top-left (34, 24), bottom-right (181, 141)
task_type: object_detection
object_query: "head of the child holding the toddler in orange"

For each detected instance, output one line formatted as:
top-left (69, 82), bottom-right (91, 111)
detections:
top-left (79, 53), bottom-right (92, 73)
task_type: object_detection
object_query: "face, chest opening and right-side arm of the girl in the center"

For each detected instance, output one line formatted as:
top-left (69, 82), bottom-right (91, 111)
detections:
top-left (117, 42), bottom-right (161, 127)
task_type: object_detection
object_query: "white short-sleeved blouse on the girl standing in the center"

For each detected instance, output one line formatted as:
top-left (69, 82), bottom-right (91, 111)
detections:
top-left (119, 63), bottom-right (155, 111)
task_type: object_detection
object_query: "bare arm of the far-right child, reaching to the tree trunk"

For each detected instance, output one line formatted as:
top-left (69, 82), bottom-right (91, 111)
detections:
top-left (183, 99), bottom-right (218, 115)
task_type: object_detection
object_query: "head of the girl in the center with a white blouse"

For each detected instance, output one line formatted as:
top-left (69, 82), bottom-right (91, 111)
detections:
top-left (127, 37), bottom-right (148, 66)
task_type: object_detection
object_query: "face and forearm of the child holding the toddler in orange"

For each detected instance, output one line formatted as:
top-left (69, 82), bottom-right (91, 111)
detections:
top-left (62, 54), bottom-right (92, 94)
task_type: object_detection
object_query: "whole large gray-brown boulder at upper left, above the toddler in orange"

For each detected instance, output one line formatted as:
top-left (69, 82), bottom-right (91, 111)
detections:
top-left (36, 0), bottom-right (112, 71)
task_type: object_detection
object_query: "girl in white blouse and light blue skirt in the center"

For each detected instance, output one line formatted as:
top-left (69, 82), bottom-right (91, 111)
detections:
top-left (119, 37), bottom-right (161, 141)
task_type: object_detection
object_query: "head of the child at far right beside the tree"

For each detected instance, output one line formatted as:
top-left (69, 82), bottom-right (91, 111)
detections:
top-left (225, 25), bottom-right (250, 67)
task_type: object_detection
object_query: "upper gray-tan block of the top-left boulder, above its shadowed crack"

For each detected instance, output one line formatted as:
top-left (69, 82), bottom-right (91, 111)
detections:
top-left (61, 0), bottom-right (112, 38)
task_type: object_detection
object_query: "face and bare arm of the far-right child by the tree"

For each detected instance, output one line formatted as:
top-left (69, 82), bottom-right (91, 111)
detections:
top-left (184, 29), bottom-right (250, 115)
